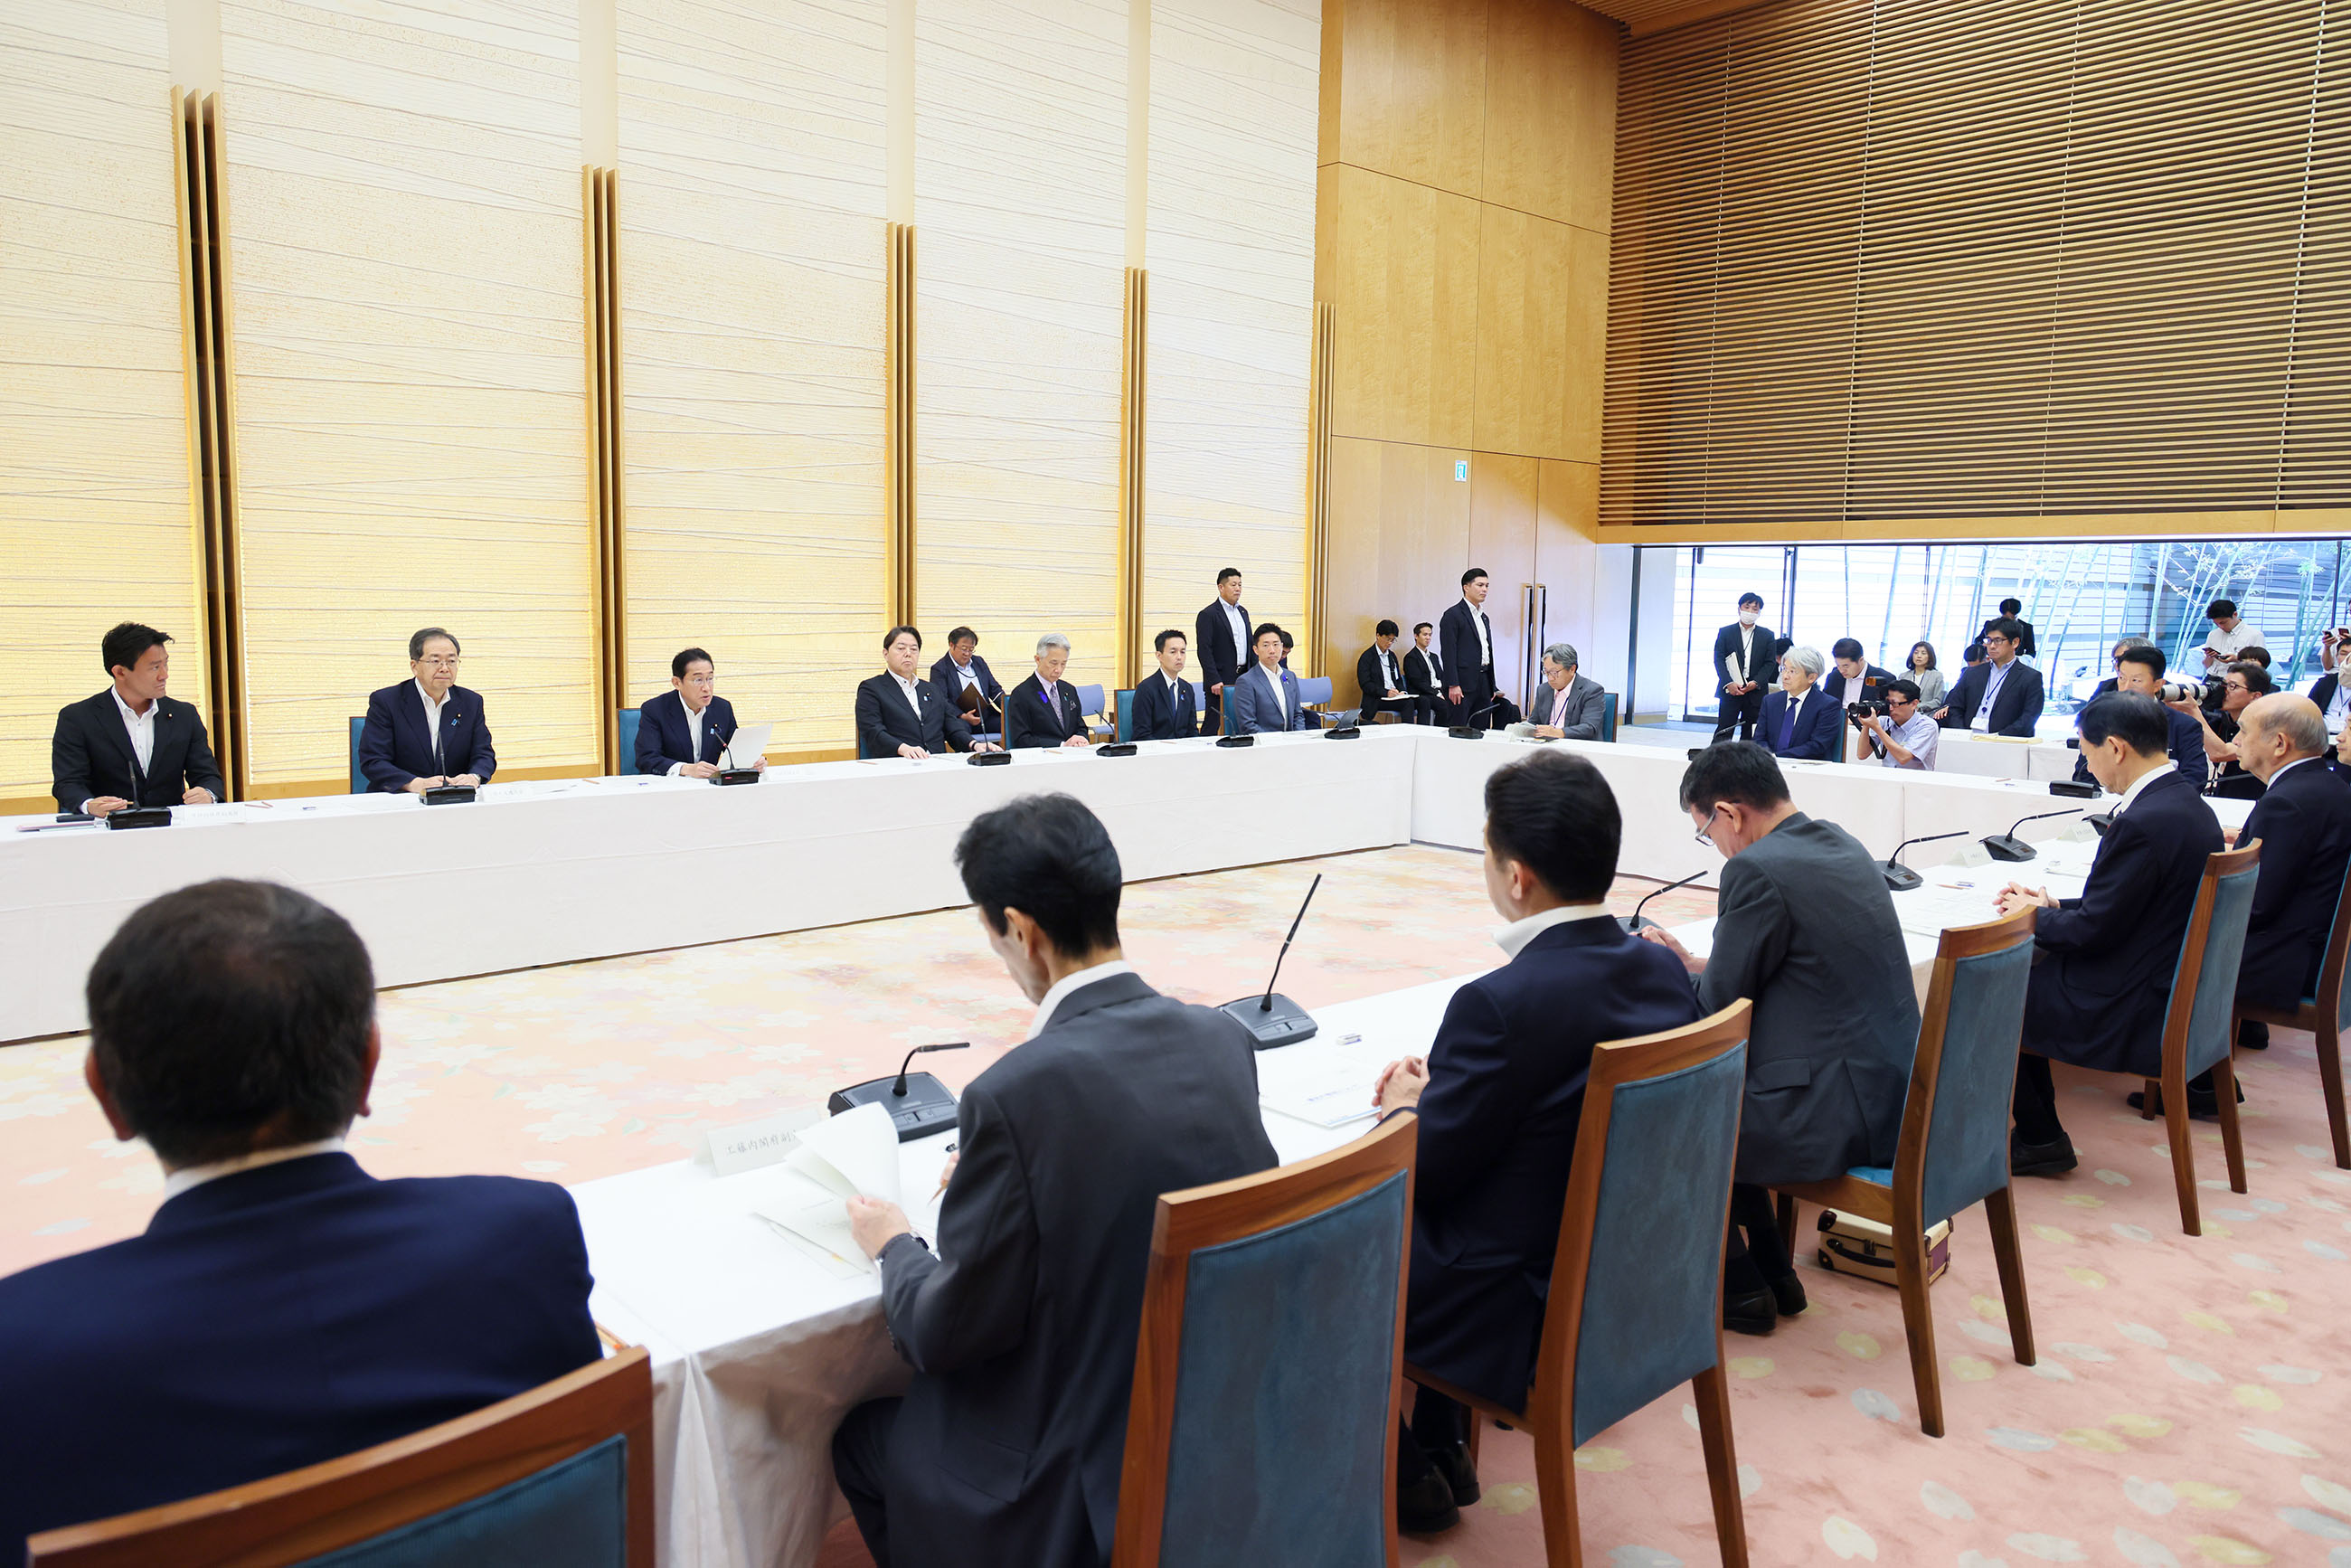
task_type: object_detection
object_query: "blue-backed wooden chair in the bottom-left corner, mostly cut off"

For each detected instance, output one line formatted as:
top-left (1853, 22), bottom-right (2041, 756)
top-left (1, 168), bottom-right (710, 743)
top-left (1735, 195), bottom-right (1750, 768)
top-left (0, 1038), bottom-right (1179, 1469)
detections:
top-left (26, 1347), bottom-right (654, 1568)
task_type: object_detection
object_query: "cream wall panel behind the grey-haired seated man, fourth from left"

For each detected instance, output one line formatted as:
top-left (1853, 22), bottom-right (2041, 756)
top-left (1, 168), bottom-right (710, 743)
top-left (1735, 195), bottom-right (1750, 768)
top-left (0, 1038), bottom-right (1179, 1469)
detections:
top-left (914, 0), bottom-right (1128, 685)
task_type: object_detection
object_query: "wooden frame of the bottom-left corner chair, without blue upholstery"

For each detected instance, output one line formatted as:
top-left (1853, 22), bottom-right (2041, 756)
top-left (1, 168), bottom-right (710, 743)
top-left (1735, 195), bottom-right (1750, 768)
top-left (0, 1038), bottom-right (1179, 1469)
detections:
top-left (26, 1347), bottom-right (654, 1568)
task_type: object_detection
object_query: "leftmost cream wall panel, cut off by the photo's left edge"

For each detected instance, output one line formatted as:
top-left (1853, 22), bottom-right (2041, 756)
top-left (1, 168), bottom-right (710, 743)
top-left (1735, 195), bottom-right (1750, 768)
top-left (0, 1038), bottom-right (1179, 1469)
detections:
top-left (0, 0), bottom-right (207, 807)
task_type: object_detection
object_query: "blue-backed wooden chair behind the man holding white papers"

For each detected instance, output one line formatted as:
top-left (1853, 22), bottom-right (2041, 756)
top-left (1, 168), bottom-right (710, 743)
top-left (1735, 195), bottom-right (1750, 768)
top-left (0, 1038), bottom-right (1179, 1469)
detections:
top-left (1109, 1117), bottom-right (1411, 1568)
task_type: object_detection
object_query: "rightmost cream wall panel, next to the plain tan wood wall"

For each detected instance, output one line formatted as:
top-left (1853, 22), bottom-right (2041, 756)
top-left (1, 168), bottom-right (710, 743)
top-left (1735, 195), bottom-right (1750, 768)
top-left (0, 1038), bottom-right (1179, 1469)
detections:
top-left (1136, 0), bottom-right (1321, 670)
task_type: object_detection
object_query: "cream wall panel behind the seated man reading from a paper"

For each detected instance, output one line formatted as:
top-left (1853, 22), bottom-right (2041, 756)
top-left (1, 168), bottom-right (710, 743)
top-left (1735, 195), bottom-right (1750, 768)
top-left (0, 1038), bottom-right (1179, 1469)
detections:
top-left (618, 0), bottom-right (889, 757)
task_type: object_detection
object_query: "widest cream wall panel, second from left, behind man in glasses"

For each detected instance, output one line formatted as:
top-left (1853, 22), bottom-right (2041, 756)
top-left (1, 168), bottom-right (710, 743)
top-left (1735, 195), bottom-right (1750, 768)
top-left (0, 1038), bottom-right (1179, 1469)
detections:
top-left (221, 0), bottom-right (597, 795)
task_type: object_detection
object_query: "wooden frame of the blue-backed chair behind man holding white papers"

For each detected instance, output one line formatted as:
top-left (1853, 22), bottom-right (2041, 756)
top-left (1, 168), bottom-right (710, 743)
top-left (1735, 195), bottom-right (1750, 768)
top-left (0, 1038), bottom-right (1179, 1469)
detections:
top-left (1109, 1117), bottom-right (1420, 1568)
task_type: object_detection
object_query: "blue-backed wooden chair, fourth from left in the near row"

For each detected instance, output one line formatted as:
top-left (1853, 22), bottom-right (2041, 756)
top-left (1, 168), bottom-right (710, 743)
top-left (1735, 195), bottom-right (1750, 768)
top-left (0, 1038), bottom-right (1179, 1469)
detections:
top-left (1780, 910), bottom-right (2034, 1436)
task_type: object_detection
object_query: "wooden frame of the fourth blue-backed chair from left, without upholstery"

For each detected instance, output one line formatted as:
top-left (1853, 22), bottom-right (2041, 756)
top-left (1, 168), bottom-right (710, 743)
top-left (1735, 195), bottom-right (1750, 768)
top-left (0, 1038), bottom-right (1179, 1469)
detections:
top-left (1778, 910), bottom-right (2034, 1436)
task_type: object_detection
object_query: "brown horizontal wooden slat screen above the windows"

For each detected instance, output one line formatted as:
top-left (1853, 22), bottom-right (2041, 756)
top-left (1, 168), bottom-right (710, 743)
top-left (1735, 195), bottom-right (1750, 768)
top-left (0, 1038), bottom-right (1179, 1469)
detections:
top-left (1601, 0), bottom-right (2351, 526)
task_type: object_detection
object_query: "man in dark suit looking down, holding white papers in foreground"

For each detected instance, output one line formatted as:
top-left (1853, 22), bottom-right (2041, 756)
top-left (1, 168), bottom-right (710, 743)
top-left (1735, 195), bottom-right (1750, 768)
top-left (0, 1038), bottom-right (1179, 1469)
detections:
top-left (832, 795), bottom-right (1277, 1568)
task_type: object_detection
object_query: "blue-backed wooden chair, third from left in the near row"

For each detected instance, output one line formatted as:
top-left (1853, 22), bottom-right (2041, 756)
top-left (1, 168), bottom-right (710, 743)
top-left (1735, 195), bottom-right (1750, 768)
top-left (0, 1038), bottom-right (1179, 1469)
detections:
top-left (1403, 1001), bottom-right (1749, 1568)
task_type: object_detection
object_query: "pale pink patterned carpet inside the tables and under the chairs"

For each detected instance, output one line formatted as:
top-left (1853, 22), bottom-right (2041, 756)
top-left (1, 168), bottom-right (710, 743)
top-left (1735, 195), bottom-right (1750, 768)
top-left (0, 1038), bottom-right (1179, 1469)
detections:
top-left (0, 848), bottom-right (2351, 1568)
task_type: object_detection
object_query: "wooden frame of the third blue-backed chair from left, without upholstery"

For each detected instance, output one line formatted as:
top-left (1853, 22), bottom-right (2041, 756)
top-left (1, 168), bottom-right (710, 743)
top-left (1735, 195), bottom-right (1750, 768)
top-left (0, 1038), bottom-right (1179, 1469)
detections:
top-left (1403, 999), bottom-right (1751, 1568)
